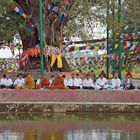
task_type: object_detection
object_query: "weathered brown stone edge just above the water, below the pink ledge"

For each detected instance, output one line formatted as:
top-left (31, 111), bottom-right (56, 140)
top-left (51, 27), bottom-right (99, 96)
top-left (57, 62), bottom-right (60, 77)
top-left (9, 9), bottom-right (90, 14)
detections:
top-left (0, 102), bottom-right (140, 113)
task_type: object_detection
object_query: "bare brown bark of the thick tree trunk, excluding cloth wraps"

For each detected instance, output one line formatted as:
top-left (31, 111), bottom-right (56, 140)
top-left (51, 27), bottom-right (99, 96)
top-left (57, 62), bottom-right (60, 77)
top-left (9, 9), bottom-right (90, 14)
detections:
top-left (17, 0), bottom-right (70, 71)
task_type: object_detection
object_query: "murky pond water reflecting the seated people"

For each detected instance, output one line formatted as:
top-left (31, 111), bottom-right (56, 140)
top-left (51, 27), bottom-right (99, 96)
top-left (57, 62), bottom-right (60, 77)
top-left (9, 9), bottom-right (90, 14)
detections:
top-left (0, 113), bottom-right (140, 140)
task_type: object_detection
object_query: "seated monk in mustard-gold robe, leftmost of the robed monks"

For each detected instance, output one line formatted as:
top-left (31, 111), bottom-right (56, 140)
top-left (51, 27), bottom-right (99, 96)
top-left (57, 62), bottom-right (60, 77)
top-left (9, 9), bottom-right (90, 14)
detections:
top-left (25, 74), bottom-right (35, 89)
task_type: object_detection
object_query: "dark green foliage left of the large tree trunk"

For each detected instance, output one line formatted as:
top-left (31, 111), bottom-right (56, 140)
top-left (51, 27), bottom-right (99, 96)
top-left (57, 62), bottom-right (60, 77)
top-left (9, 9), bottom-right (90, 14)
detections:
top-left (0, 0), bottom-right (25, 41)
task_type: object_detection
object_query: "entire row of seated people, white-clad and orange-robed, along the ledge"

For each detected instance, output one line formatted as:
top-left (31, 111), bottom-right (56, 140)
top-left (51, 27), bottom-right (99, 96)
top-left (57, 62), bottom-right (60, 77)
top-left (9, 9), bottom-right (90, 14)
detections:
top-left (0, 72), bottom-right (139, 90)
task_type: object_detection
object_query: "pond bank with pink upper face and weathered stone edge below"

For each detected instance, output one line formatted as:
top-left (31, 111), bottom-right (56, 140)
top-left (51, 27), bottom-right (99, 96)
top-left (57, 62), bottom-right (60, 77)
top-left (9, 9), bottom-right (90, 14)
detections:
top-left (0, 90), bottom-right (140, 113)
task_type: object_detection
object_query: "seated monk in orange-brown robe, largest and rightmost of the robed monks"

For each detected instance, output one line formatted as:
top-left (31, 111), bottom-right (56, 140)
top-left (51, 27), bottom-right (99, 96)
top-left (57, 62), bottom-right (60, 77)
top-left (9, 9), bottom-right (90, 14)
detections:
top-left (50, 74), bottom-right (67, 89)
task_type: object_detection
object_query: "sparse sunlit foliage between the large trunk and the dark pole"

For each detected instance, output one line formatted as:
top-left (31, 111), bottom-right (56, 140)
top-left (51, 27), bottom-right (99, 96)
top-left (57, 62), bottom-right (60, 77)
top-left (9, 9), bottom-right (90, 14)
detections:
top-left (65, 0), bottom-right (105, 40)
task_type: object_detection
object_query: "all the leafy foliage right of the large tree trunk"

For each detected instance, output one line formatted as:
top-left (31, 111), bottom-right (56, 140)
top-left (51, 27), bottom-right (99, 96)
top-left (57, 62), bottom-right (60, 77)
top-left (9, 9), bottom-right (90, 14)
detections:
top-left (65, 0), bottom-right (140, 39)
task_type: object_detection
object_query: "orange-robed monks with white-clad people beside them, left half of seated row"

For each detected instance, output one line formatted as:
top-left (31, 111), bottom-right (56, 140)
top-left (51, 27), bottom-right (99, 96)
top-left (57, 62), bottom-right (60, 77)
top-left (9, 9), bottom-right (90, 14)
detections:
top-left (0, 74), bottom-right (67, 89)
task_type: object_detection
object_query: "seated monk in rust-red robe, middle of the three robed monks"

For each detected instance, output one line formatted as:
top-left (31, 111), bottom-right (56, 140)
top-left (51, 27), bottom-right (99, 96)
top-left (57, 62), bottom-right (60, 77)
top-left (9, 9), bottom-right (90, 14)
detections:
top-left (36, 76), bottom-right (50, 89)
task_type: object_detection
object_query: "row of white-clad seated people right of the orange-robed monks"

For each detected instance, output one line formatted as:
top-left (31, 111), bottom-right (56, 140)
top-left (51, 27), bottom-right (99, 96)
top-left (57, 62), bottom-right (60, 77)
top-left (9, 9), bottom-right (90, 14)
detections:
top-left (63, 73), bottom-right (135, 90)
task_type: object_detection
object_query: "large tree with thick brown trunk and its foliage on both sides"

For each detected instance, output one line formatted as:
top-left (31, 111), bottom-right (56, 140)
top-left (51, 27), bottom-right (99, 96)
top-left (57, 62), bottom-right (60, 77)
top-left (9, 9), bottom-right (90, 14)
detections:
top-left (0, 0), bottom-right (140, 71)
